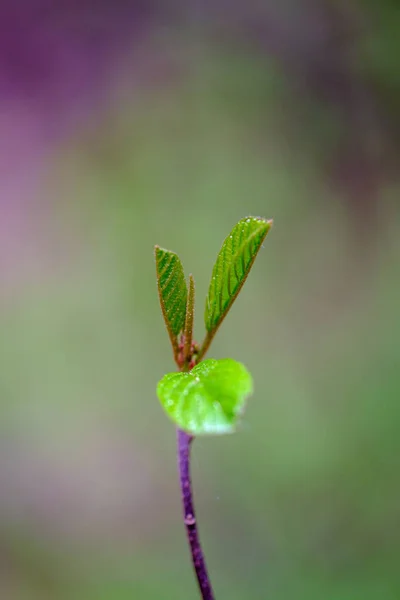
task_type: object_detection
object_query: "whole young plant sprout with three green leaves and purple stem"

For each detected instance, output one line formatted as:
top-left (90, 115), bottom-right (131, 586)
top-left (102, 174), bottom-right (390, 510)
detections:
top-left (155, 217), bottom-right (272, 600)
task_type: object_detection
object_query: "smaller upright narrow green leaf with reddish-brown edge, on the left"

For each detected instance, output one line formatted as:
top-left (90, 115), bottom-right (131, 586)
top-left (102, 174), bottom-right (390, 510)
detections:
top-left (155, 246), bottom-right (187, 351)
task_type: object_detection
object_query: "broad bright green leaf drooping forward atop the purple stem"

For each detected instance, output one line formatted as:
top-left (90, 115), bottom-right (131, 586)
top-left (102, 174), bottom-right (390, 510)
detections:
top-left (157, 358), bottom-right (253, 435)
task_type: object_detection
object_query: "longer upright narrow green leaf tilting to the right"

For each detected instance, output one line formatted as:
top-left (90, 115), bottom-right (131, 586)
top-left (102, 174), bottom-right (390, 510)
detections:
top-left (204, 217), bottom-right (272, 334)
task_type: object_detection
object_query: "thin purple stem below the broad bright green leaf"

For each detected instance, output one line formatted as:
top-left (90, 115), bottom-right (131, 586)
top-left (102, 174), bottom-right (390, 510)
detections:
top-left (177, 429), bottom-right (215, 600)
